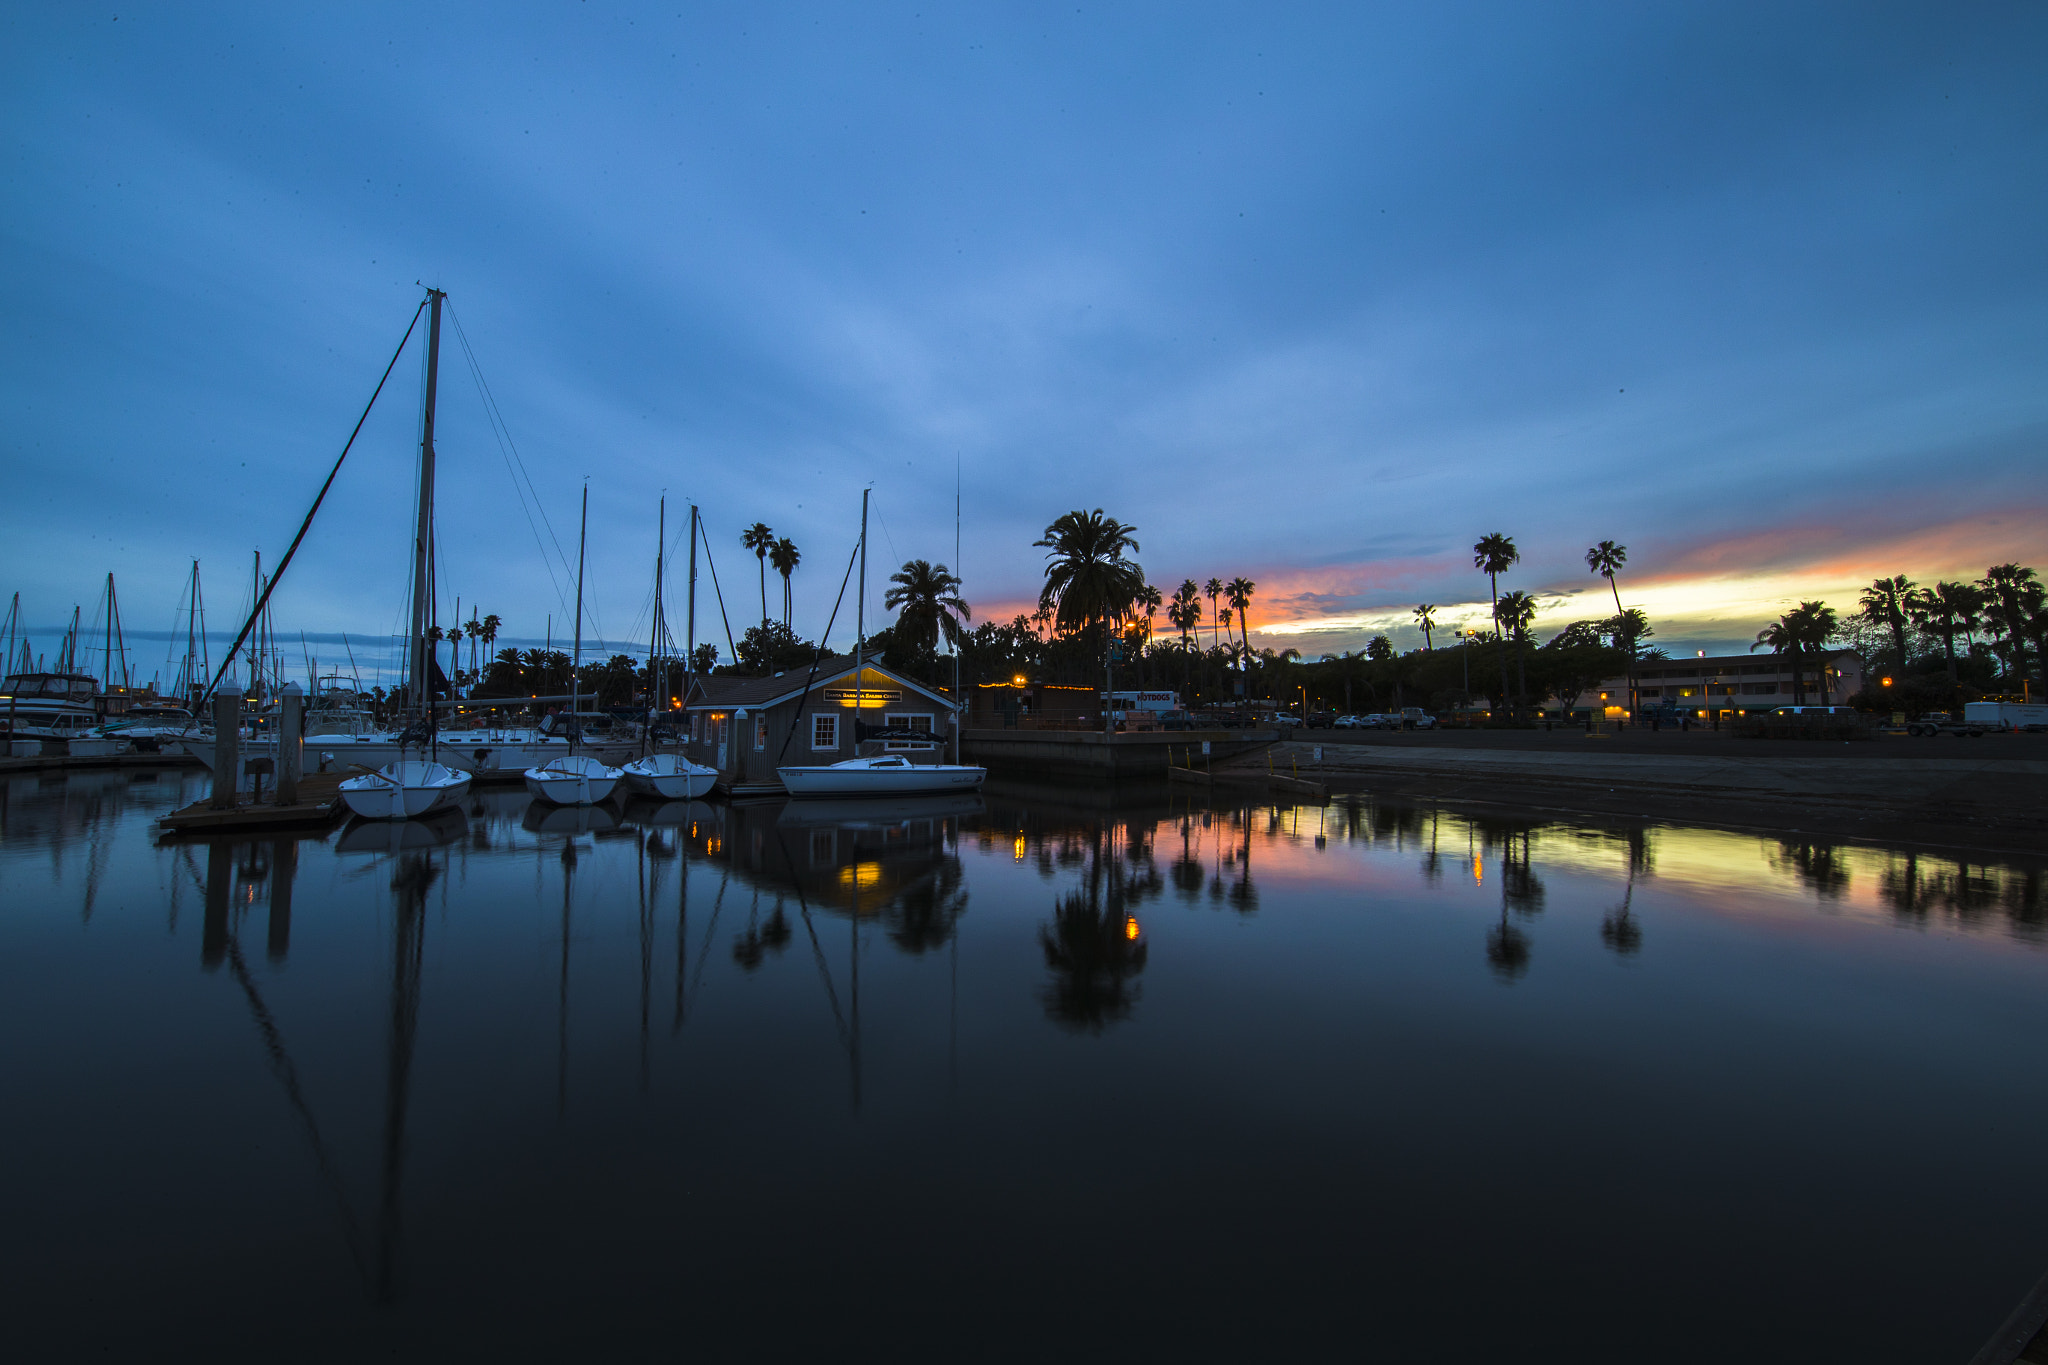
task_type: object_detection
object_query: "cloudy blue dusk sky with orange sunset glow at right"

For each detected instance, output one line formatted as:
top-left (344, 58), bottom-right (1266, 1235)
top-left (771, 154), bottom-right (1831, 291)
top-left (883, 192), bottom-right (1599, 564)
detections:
top-left (0, 0), bottom-right (2048, 683)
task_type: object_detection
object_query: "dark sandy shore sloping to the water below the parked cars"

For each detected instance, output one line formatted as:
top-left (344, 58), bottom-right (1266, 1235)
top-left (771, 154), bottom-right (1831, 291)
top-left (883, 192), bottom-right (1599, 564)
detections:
top-left (1233, 731), bottom-right (2048, 855)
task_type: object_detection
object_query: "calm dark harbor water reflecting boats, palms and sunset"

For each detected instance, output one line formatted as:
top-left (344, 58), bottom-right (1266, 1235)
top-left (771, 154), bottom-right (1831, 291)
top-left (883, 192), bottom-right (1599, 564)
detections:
top-left (0, 774), bottom-right (2048, 1361)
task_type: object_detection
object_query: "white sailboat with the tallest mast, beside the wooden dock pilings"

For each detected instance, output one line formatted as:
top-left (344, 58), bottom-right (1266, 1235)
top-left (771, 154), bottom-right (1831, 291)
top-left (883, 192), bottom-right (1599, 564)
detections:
top-left (340, 289), bottom-right (469, 821)
